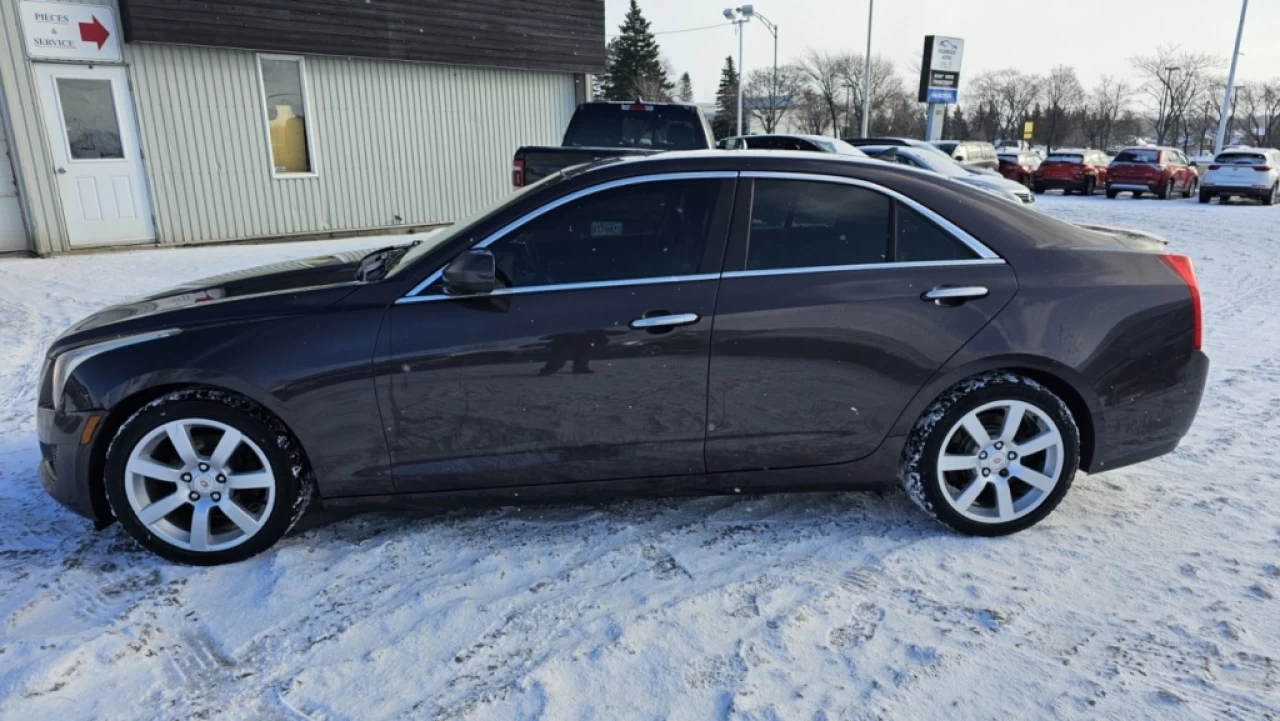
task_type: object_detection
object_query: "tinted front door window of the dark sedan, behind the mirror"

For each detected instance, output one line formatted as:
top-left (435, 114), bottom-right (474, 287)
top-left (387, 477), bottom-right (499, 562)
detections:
top-left (489, 181), bottom-right (721, 288)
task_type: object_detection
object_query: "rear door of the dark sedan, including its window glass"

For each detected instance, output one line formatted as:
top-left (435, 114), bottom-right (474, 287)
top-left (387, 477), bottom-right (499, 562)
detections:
top-left (707, 173), bottom-right (1016, 473)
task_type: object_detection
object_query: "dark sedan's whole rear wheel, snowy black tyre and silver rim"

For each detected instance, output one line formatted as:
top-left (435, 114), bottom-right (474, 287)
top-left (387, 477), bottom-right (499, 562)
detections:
top-left (900, 373), bottom-right (1080, 535)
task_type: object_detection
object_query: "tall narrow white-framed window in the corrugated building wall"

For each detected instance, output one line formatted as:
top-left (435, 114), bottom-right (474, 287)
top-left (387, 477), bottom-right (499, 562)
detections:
top-left (257, 55), bottom-right (315, 175)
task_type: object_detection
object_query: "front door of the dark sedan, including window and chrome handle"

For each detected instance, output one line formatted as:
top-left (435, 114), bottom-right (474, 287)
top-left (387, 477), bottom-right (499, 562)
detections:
top-left (379, 173), bottom-right (736, 492)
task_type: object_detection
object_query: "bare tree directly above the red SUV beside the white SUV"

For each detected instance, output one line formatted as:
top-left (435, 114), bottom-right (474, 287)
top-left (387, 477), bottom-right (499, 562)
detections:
top-left (1129, 45), bottom-right (1221, 145)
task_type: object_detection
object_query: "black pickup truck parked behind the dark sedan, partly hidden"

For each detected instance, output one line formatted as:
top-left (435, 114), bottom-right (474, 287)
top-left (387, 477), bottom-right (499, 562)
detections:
top-left (511, 101), bottom-right (716, 188)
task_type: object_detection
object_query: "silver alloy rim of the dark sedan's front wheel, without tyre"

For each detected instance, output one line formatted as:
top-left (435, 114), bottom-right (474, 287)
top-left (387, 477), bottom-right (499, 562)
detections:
top-left (124, 417), bottom-right (275, 552)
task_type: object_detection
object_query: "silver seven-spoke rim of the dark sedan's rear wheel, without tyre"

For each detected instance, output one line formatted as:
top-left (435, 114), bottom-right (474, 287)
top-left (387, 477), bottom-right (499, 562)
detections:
top-left (937, 401), bottom-right (1066, 524)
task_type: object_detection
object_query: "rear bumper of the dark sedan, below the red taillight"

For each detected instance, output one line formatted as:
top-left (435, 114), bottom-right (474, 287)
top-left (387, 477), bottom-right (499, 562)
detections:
top-left (1084, 351), bottom-right (1208, 474)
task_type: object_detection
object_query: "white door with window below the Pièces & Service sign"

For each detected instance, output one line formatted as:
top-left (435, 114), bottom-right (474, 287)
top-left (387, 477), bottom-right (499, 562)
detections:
top-left (36, 64), bottom-right (155, 246)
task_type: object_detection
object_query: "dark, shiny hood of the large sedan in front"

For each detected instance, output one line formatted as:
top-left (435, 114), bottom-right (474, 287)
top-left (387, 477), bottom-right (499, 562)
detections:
top-left (51, 250), bottom-right (369, 351)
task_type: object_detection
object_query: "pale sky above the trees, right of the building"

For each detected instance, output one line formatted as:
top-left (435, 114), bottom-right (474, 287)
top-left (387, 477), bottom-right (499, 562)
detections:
top-left (604, 0), bottom-right (1280, 102)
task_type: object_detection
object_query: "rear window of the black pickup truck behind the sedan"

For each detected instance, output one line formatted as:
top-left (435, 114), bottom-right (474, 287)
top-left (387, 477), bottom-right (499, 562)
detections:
top-left (564, 102), bottom-right (704, 150)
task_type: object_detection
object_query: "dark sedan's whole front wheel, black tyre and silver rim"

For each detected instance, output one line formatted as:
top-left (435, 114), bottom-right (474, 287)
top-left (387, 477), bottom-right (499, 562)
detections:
top-left (106, 391), bottom-right (312, 566)
